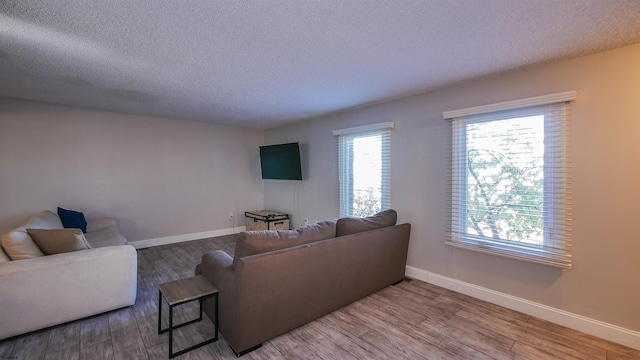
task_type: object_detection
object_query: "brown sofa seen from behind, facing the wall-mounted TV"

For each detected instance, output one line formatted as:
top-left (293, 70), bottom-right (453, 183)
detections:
top-left (196, 210), bottom-right (411, 355)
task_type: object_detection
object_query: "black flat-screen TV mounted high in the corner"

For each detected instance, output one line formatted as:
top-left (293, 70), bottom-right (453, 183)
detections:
top-left (260, 143), bottom-right (302, 180)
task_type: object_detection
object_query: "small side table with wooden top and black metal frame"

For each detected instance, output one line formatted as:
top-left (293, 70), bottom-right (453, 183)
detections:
top-left (158, 275), bottom-right (218, 359)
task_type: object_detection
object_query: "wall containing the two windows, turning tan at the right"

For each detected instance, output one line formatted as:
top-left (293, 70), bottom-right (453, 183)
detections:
top-left (264, 44), bottom-right (640, 331)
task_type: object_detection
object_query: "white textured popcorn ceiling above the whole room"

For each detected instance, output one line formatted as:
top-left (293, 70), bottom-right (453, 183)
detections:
top-left (0, 0), bottom-right (640, 128)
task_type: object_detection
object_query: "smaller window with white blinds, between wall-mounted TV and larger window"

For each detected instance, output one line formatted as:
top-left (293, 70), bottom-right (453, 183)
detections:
top-left (333, 122), bottom-right (394, 217)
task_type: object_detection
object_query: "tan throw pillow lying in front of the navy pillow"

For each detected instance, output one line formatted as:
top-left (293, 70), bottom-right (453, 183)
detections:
top-left (27, 229), bottom-right (91, 255)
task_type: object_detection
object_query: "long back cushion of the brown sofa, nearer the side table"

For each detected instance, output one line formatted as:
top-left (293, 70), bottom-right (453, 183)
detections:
top-left (231, 221), bottom-right (336, 269)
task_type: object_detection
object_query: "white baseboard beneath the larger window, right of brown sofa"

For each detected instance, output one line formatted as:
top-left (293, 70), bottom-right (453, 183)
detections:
top-left (406, 266), bottom-right (640, 350)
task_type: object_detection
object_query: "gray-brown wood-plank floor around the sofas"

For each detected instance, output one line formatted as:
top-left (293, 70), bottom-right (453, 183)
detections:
top-left (0, 235), bottom-right (640, 360)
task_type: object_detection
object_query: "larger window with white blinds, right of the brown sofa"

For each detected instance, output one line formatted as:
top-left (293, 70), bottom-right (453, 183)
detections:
top-left (443, 92), bottom-right (576, 268)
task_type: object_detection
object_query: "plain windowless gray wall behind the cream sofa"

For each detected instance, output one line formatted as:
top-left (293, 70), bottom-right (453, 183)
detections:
top-left (0, 98), bottom-right (264, 240)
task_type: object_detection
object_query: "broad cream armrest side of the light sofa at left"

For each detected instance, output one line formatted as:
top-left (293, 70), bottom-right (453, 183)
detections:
top-left (0, 245), bottom-right (137, 339)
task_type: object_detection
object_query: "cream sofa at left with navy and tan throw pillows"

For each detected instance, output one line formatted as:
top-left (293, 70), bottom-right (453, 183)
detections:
top-left (0, 211), bottom-right (137, 340)
